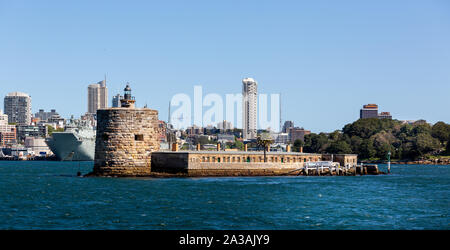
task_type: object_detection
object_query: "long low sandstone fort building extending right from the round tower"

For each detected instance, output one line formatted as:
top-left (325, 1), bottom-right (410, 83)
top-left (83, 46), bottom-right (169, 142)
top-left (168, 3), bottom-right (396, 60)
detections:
top-left (151, 150), bottom-right (358, 177)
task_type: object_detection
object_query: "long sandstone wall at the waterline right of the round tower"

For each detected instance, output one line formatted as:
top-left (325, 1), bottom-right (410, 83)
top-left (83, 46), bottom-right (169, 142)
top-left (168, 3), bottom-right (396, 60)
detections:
top-left (152, 151), bottom-right (355, 177)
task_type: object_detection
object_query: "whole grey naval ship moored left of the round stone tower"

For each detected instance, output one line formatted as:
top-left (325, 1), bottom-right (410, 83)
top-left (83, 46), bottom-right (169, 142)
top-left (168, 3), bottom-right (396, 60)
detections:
top-left (46, 118), bottom-right (96, 161)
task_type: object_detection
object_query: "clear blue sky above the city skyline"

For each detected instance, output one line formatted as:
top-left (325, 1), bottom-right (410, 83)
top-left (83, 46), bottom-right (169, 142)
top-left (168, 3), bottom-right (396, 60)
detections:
top-left (0, 0), bottom-right (450, 132)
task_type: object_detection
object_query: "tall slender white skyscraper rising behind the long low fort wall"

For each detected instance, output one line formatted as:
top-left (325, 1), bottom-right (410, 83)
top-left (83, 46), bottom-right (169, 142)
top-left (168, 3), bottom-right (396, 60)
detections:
top-left (242, 78), bottom-right (258, 140)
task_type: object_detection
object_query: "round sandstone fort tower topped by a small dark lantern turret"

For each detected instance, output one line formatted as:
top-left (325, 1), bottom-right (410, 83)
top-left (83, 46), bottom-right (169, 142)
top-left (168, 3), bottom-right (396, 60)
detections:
top-left (92, 84), bottom-right (159, 177)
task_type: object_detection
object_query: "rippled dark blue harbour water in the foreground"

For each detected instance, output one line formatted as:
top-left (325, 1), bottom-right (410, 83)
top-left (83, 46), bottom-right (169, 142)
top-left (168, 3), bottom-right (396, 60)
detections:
top-left (0, 161), bottom-right (450, 230)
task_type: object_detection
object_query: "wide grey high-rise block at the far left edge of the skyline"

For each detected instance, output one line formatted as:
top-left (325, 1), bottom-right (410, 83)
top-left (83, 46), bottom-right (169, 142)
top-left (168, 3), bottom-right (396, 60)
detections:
top-left (3, 92), bottom-right (31, 125)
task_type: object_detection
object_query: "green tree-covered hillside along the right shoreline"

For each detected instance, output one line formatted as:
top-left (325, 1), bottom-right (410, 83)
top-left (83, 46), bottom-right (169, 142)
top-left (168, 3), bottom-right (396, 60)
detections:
top-left (294, 118), bottom-right (450, 159)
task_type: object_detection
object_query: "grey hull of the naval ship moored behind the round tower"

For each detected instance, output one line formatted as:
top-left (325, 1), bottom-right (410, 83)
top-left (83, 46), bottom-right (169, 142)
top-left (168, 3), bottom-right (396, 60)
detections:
top-left (46, 132), bottom-right (95, 161)
